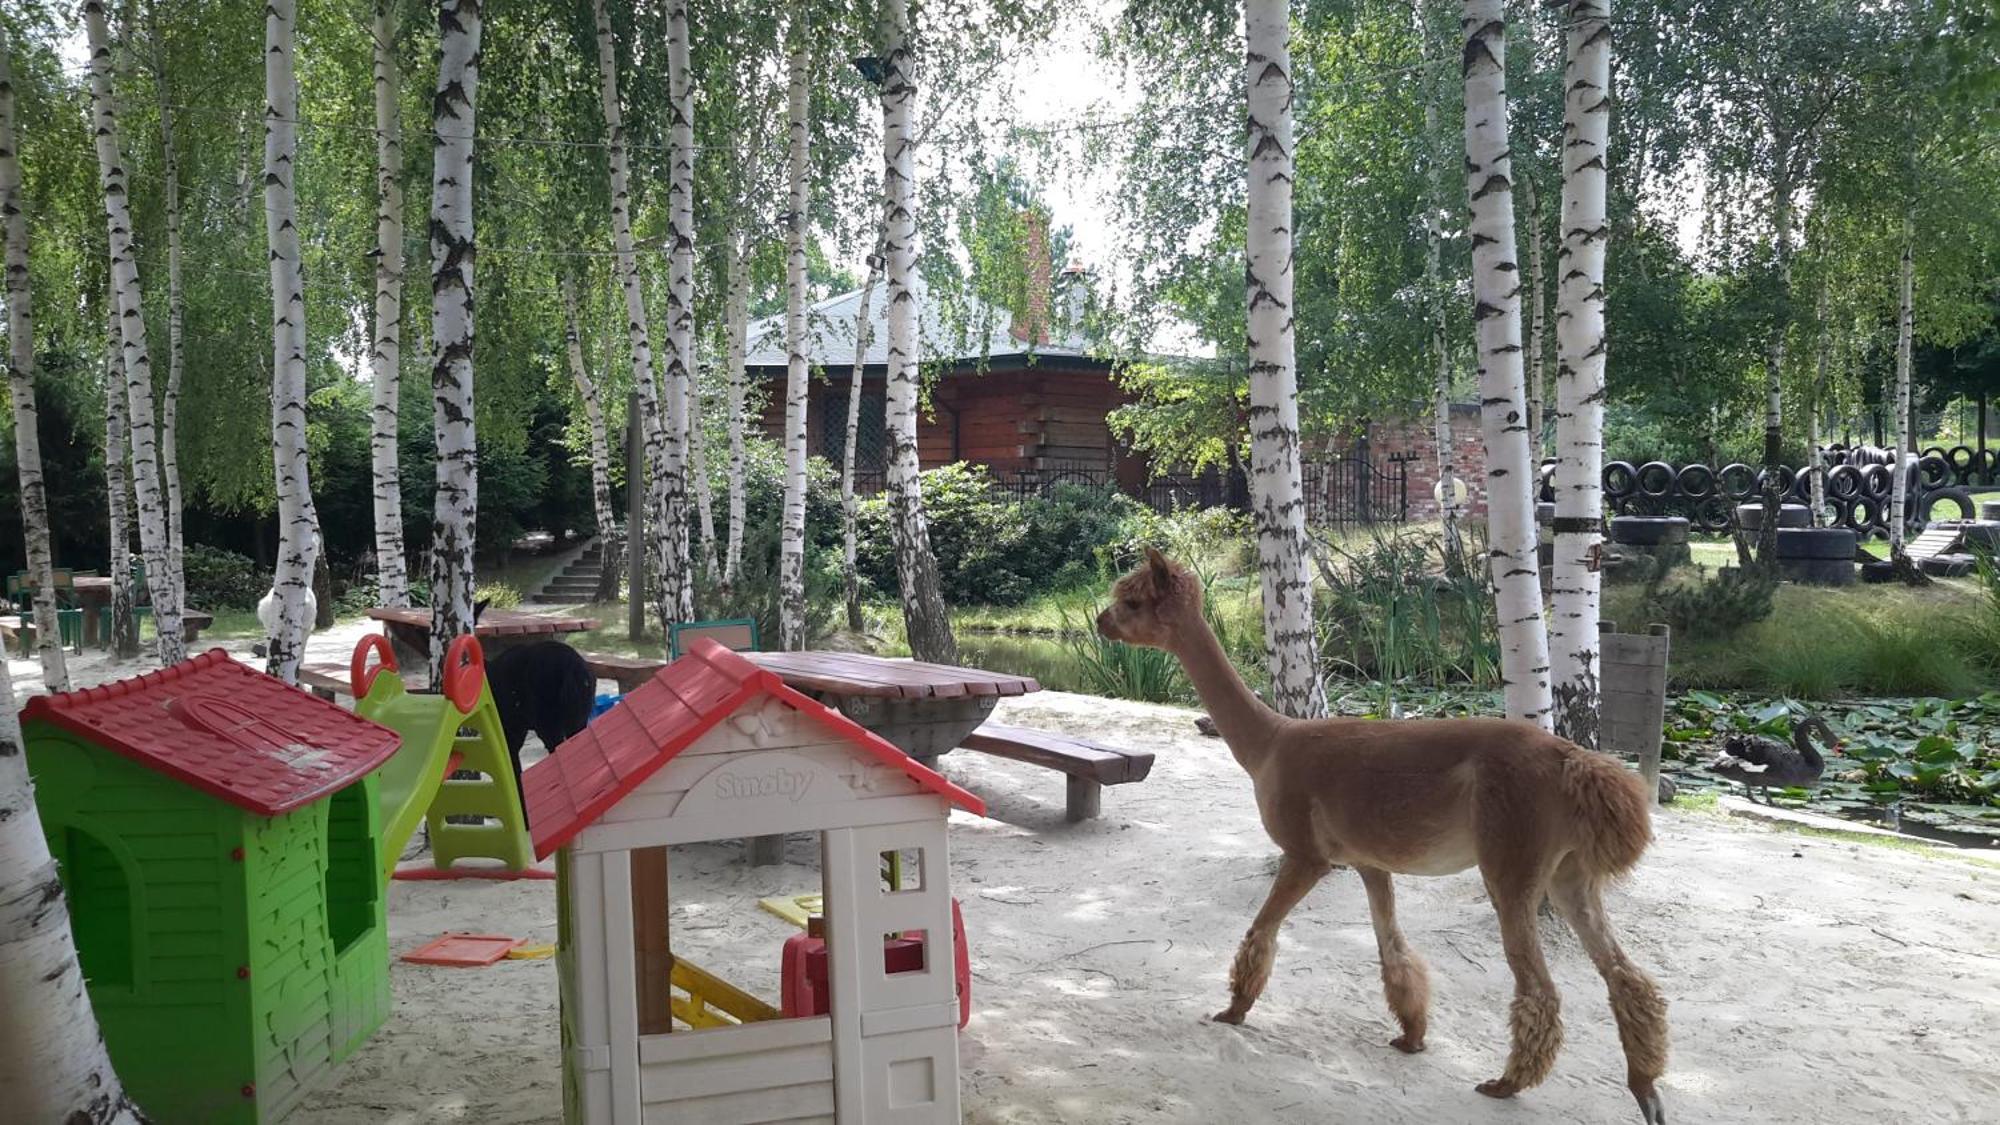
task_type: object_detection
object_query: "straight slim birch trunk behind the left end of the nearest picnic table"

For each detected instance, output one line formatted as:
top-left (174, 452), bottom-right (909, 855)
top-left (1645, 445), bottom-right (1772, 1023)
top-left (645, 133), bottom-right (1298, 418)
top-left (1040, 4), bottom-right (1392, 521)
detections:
top-left (778, 24), bottom-right (812, 653)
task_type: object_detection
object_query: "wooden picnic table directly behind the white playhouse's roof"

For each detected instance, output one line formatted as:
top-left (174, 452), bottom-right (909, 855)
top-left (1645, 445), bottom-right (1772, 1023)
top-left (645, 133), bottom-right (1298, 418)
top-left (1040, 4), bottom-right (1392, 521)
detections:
top-left (744, 653), bottom-right (1042, 765)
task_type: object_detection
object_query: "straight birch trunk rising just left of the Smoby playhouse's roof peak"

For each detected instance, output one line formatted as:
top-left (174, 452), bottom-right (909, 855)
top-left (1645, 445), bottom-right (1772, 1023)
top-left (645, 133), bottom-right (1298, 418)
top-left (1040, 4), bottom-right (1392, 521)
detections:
top-left (658, 0), bottom-right (694, 629)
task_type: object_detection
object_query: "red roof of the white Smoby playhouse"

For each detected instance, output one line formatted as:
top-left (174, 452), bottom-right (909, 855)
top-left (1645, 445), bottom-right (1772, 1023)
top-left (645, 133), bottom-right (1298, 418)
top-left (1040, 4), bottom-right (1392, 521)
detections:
top-left (522, 637), bottom-right (986, 859)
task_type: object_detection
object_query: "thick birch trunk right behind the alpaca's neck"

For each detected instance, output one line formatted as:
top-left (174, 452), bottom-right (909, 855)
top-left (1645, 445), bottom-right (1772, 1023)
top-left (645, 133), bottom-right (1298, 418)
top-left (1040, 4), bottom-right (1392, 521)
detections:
top-left (1244, 0), bottom-right (1326, 719)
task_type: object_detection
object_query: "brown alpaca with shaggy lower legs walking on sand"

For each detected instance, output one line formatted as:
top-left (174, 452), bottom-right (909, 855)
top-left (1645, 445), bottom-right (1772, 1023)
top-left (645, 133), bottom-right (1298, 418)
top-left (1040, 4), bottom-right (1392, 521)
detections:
top-left (1098, 548), bottom-right (1666, 1125)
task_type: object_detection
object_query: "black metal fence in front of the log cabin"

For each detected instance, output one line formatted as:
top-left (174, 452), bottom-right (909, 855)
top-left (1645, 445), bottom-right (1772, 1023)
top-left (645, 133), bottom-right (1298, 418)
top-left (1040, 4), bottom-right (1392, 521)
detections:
top-left (854, 456), bottom-right (1410, 526)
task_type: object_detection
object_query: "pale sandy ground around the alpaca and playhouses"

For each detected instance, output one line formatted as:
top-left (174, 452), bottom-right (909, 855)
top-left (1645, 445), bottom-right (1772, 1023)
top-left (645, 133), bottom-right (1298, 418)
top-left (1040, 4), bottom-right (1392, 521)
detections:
top-left (12, 631), bottom-right (2000, 1125)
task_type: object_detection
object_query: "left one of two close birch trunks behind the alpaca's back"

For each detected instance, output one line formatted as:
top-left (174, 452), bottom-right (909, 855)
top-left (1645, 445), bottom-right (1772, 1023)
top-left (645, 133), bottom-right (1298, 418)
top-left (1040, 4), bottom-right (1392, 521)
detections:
top-left (1464, 0), bottom-right (1550, 729)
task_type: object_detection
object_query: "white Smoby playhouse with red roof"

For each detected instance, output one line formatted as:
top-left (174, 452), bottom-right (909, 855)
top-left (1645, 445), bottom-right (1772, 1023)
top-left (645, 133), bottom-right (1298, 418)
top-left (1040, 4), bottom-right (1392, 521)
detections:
top-left (524, 641), bottom-right (984, 1125)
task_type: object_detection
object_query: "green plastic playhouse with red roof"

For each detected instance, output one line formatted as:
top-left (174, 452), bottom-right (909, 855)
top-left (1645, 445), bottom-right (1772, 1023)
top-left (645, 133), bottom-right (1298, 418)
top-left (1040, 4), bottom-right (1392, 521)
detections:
top-left (22, 649), bottom-right (398, 1123)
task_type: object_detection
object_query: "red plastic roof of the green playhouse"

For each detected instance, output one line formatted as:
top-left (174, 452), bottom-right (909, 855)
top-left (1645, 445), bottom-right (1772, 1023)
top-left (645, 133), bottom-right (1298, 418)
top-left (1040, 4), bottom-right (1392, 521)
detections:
top-left (22, 649), bottom-right (402, 817)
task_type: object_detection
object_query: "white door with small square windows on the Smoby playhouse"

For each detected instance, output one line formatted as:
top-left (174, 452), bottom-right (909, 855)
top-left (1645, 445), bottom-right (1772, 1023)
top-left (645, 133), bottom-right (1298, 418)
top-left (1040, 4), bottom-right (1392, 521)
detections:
top-left (826, 817), bottom-right (960, 1125)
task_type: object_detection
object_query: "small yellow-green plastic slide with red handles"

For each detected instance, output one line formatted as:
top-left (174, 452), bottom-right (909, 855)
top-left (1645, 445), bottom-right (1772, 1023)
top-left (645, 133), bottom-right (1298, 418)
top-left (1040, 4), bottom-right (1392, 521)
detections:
top-left (348, 633), bottom-right (536, 879)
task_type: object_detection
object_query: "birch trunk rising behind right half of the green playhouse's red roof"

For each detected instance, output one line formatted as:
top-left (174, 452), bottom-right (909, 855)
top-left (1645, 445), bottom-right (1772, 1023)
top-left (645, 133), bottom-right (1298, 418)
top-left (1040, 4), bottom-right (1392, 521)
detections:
top-left (264, 0), bottom-right (320, 683)
